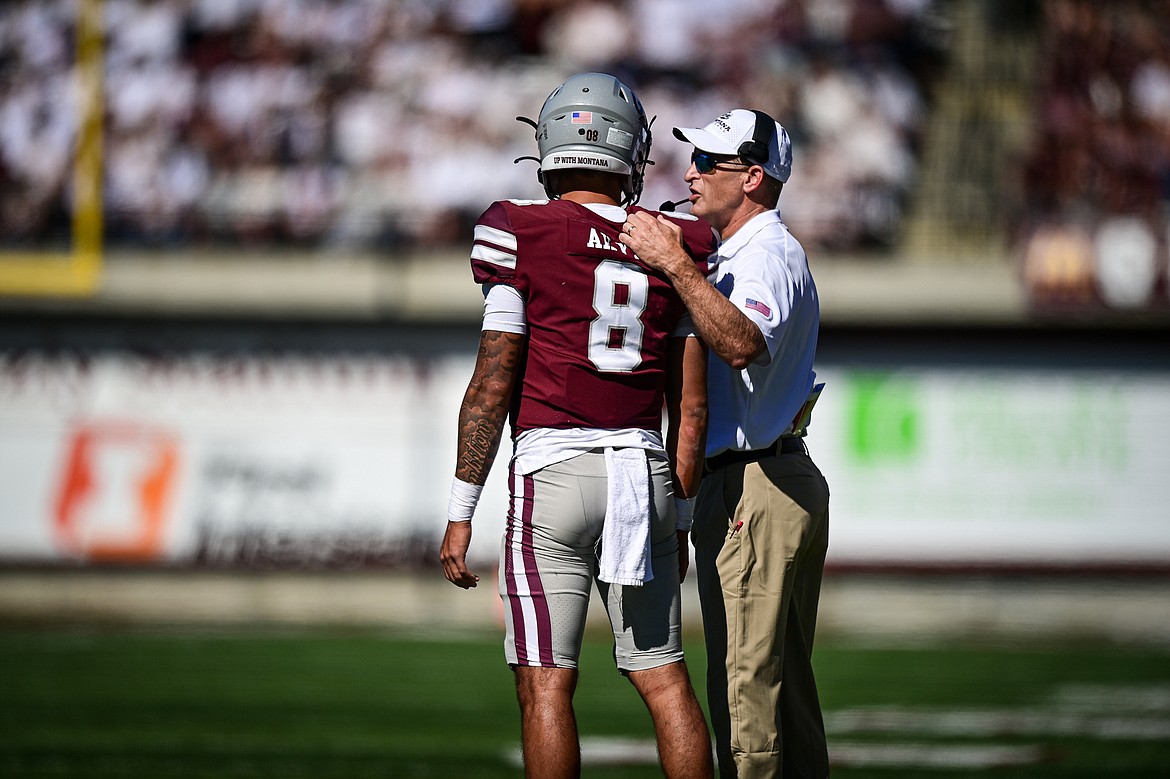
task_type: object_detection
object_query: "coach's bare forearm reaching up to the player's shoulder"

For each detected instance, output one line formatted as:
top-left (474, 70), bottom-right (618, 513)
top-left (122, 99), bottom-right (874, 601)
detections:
top-left (665, 251), bottom-right (768, 370)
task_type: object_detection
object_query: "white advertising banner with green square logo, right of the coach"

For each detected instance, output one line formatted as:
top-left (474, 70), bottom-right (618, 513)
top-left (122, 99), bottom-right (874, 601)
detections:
top-left (808, 368), bottom-right (1170, 565)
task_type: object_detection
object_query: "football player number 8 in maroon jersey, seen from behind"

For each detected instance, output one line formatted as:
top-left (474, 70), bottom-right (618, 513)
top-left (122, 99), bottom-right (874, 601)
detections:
top-left (440, 73), bottom-right (716, 777)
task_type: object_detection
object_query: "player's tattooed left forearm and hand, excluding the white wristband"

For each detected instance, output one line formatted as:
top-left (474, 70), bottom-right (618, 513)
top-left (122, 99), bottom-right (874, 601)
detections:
top-left (439, 330), bottom-right (527, 590)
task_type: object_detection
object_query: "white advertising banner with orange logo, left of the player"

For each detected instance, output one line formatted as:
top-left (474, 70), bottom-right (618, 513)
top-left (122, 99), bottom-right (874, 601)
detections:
top-left (0, 354), bottom-right (507, 567)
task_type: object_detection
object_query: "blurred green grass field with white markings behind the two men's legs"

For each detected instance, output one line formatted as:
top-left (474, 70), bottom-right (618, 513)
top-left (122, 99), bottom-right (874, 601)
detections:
top-left (0, 626), bottom-right (1170, 779)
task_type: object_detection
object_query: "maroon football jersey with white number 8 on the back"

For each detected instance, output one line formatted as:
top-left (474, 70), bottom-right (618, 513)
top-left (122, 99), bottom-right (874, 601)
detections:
top-left (472, 200), bottom-right (716, 437)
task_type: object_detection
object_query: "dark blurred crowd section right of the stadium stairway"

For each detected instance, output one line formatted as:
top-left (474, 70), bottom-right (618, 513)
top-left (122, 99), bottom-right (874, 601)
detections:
top-left (1011, 0), bottom-right (1170, 308)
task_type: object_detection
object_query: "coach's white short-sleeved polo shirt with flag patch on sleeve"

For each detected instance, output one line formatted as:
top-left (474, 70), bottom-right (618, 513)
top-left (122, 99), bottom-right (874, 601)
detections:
top-left (707, 211), bottom-right (820, 457)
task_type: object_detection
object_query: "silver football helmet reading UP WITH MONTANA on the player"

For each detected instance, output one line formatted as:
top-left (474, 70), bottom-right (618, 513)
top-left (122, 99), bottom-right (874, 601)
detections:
top-left (535, 73), bottom-right (651, 205)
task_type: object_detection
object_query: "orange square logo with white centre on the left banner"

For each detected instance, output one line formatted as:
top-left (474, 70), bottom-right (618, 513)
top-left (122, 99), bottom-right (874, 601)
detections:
top-left (55, 423), bottom-right (179, 563)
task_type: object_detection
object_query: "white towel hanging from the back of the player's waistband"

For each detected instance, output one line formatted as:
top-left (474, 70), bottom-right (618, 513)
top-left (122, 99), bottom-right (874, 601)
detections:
top-left (598, 447), bottom-right (654, 587)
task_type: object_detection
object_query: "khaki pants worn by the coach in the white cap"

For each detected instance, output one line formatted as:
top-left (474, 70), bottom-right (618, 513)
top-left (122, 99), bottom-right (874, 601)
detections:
top-left (693, 453), bottom-right (828, 779)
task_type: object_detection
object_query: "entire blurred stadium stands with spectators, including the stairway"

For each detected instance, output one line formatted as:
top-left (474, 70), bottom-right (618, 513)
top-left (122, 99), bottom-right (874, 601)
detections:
top-left (0, 0), bottom-right (1170, 311)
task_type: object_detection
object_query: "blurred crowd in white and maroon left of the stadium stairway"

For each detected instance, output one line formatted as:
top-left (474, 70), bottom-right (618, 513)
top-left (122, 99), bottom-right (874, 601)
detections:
top-left (0, 0), bottom-right (940, 251)
